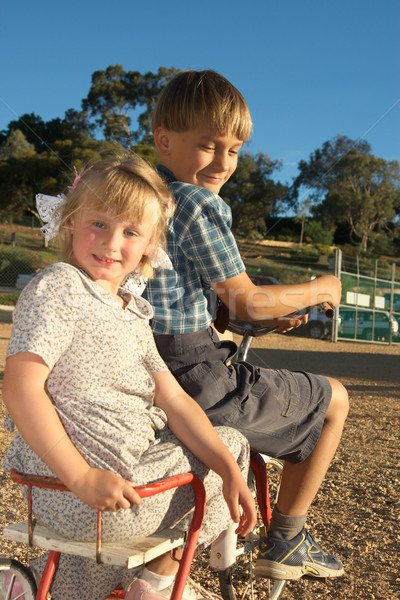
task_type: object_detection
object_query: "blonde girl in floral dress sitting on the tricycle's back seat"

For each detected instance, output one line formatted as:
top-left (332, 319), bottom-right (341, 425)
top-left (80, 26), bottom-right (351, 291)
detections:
top-left (3, 154), bottom-right (255, 600)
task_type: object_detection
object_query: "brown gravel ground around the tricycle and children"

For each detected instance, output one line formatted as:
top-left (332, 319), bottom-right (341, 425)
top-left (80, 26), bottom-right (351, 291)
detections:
top-left (0, 323), bottom-right (400, 600)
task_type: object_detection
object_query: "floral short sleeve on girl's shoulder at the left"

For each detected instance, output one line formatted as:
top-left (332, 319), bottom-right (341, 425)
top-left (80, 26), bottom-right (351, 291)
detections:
top-left (7, 263), bottom-right (82, 370)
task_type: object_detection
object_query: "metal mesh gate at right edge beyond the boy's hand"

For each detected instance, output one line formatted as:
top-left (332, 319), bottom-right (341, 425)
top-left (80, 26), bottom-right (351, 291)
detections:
top-left (333, 250), bottom-right (400, 344)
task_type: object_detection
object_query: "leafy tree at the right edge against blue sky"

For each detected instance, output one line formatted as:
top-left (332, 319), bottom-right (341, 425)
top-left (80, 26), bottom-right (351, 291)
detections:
top-left (291, 136), bottom-right (400, 251)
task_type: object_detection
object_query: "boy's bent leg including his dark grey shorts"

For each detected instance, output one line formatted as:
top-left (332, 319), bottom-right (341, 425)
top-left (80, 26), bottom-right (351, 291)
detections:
top-left (156, 331), bottom-right (348, 579)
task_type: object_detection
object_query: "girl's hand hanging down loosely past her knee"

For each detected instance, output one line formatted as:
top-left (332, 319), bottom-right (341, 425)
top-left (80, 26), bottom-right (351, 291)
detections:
top-left (222, 471), bottom-right (257, 537)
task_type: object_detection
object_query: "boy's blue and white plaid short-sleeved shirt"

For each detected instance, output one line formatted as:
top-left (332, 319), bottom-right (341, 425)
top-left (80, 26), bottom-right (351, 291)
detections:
top-left (143, 166), bottom-right (245, 334)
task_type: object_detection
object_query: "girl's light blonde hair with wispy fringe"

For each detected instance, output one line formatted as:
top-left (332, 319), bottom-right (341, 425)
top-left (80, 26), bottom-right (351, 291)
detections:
top-left (59, 152), bottom-right (172, 277)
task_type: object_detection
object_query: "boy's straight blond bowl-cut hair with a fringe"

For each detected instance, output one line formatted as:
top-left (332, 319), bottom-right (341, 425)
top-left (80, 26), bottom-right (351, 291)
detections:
top-left (152, 69), bottom-right (252, 142)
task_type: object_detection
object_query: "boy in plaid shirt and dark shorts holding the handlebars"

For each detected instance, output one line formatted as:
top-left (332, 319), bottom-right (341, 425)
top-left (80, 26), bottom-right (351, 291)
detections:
top-left (144, 70), bottom-right (348, 579)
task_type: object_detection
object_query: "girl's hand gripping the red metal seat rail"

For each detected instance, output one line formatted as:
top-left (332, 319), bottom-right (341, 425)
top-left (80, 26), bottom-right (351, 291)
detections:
top-left (70, 467), bottom-right (142, 512)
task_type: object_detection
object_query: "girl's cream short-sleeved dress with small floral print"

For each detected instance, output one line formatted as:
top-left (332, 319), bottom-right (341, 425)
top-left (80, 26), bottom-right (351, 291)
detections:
top-left (4, 263), bottom-right (249, 600)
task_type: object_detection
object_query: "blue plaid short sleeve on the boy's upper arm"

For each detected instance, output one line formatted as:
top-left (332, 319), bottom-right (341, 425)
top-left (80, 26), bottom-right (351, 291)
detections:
top-left (173, 188), bottom-right (245, 283)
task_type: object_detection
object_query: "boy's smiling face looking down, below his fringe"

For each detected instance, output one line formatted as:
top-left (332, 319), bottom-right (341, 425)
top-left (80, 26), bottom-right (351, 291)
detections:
top-left (154, 127), bottom-right (243, 194)
